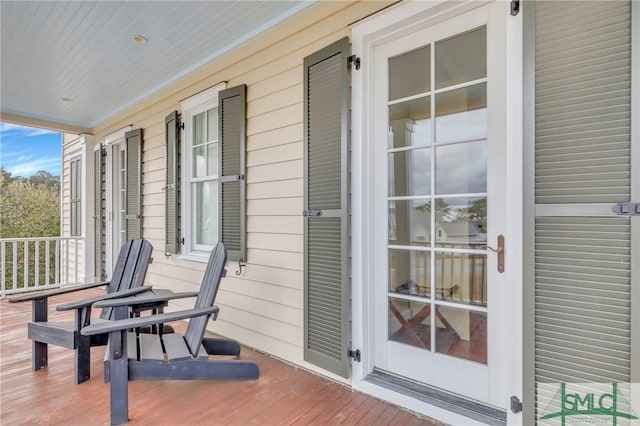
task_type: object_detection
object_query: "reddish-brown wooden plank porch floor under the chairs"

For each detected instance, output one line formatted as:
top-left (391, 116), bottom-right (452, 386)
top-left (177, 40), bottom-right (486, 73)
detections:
top-left (0, 290), bottom-right (436, 426)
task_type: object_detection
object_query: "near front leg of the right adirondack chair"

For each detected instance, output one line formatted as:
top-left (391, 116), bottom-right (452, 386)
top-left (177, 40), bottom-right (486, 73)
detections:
top-left (109, 331), bottom-right (129, 425)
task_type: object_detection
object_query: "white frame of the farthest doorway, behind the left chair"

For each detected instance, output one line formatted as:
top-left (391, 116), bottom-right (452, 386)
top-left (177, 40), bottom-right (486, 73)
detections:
top-left (104, 126), bottom-right (132, 279)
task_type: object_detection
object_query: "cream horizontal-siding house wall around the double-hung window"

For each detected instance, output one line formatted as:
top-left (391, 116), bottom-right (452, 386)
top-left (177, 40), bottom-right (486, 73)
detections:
top-left (90, 2), bottom-right (388, 380)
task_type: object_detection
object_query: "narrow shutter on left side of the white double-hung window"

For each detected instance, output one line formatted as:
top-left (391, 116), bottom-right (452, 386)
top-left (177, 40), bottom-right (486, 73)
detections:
top-left (164, 111), bottom-right (180, 253)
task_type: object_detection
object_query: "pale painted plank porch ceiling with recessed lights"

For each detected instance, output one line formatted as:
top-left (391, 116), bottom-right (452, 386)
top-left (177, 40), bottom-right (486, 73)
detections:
top-left (0, 0), bottom-right (314, 128)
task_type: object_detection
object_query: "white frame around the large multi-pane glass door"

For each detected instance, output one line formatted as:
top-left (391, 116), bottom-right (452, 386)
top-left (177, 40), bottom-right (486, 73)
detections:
top-left (351, 1), bottom-right (523, 424)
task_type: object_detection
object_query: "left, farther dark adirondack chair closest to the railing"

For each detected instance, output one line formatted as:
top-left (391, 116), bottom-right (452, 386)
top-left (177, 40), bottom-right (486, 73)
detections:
top-left (9, 239), bottom-right (153, 383)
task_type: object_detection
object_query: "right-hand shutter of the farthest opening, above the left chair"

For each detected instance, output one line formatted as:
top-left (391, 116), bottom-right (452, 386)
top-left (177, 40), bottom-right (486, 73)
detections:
top-left (124, 129), bottom-right (142, 242)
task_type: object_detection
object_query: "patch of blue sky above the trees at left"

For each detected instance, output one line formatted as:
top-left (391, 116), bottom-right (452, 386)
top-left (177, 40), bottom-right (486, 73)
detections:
top-left (0, 123), bottom-right (62, 177)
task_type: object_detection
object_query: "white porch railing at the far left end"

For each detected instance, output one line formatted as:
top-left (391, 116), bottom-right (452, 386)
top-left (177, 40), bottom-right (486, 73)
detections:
top-left (0, 236), bottom-right (84, 297)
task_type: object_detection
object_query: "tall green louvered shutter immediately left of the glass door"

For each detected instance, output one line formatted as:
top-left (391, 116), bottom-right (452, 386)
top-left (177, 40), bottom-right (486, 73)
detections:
top-left (303, 38), bottom-right (350, 377)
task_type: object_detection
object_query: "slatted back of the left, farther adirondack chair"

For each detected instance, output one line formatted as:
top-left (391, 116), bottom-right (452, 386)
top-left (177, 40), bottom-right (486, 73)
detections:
top-left (100, 239), bottom-right (153, 320)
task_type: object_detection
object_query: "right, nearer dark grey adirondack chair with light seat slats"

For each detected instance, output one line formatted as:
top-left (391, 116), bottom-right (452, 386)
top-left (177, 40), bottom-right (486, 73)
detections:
top-left (82, 243), bottom-right (259, 424)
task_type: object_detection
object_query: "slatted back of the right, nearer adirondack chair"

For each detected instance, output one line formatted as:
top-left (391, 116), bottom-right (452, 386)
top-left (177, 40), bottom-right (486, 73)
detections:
top-left (184, 242), bottom-right (227, 356)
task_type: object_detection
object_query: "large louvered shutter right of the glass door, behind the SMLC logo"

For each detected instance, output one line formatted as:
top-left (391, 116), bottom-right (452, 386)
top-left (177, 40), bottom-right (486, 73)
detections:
top-left (532, 1), bottom-right (640, 415)
